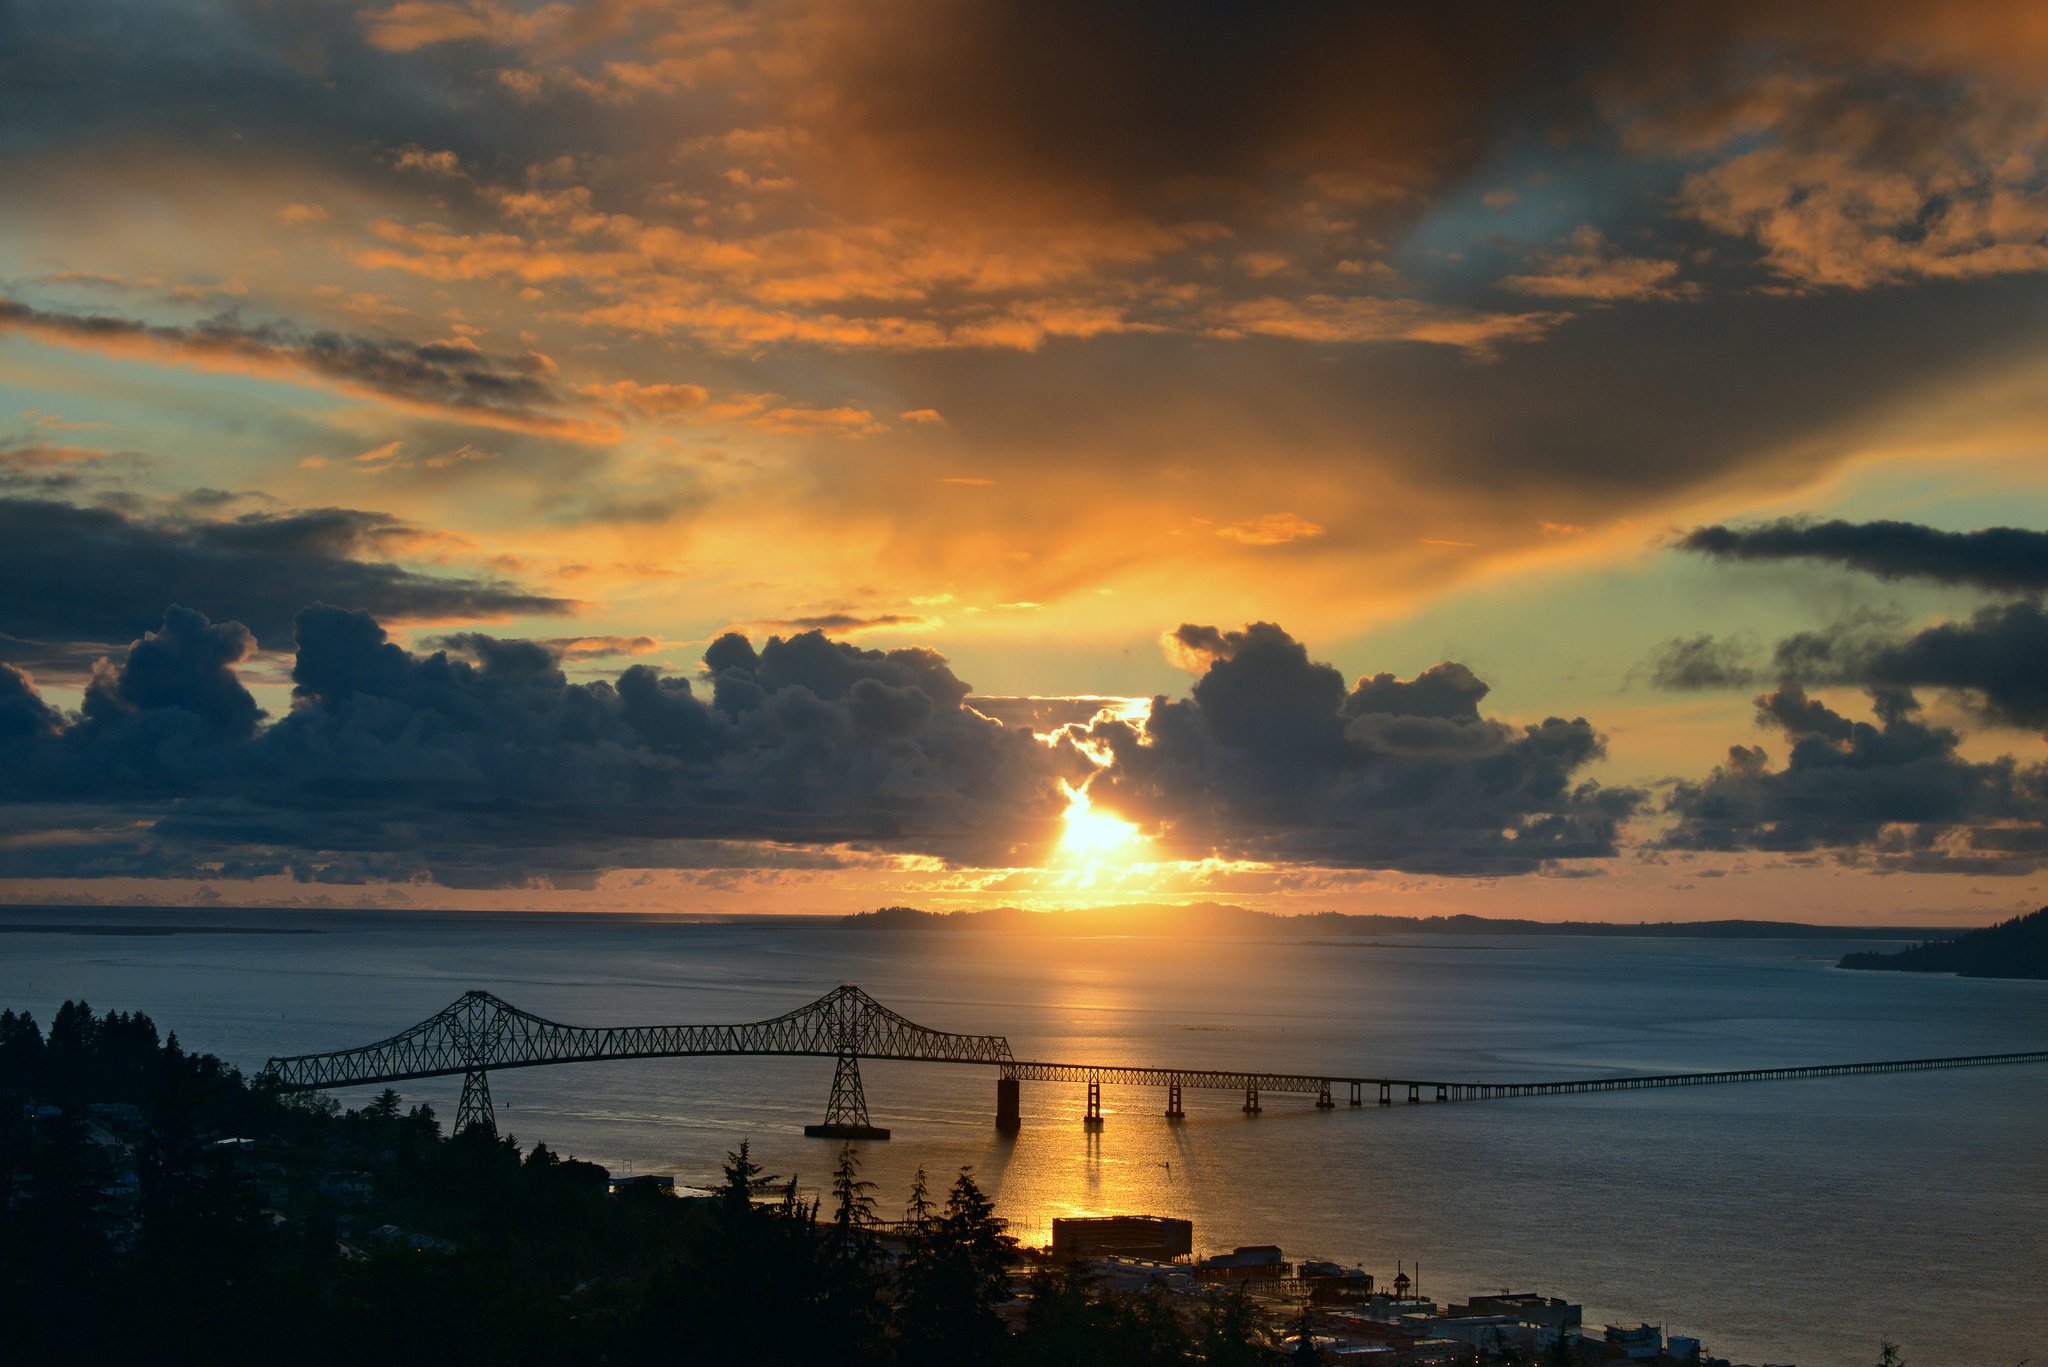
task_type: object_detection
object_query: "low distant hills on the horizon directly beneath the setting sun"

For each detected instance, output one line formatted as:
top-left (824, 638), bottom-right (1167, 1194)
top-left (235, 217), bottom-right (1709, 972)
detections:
top-left (842, 902), bottom-right (1931, 941)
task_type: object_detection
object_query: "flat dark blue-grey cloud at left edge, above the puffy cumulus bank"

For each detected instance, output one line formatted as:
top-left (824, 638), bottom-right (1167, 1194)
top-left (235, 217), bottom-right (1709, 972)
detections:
top-left (0, 498), bottom-right (578, 668)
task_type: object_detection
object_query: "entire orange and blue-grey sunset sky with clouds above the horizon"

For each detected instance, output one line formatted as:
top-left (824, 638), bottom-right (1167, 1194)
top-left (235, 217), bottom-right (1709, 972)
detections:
top-left (0, 0), bottom-right (2048, 924)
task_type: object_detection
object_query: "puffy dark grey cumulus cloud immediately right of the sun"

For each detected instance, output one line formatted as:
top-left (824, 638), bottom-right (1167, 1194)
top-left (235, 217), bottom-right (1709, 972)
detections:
top-left (1077, 623), bottom-right (1640, 875)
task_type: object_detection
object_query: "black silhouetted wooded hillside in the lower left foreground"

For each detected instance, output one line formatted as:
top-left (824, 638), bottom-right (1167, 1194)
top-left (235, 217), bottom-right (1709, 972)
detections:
top-left (0, 1002), bottom-right (1294, 1367)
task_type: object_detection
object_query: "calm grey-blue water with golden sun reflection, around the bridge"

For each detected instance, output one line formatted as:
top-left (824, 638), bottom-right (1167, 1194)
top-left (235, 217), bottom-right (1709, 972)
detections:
top-left (0, 910), bottom-right (2048, 1367)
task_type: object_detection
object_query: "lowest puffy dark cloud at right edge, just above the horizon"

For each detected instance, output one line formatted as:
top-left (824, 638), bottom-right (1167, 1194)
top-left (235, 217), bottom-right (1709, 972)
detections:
top-left (1663, 687), bottom-right (2048, 873)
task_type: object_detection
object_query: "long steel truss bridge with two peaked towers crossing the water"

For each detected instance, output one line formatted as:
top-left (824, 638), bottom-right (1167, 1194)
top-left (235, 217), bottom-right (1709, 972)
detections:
top-left (260, 984), bottom-right (2048, 1140)
